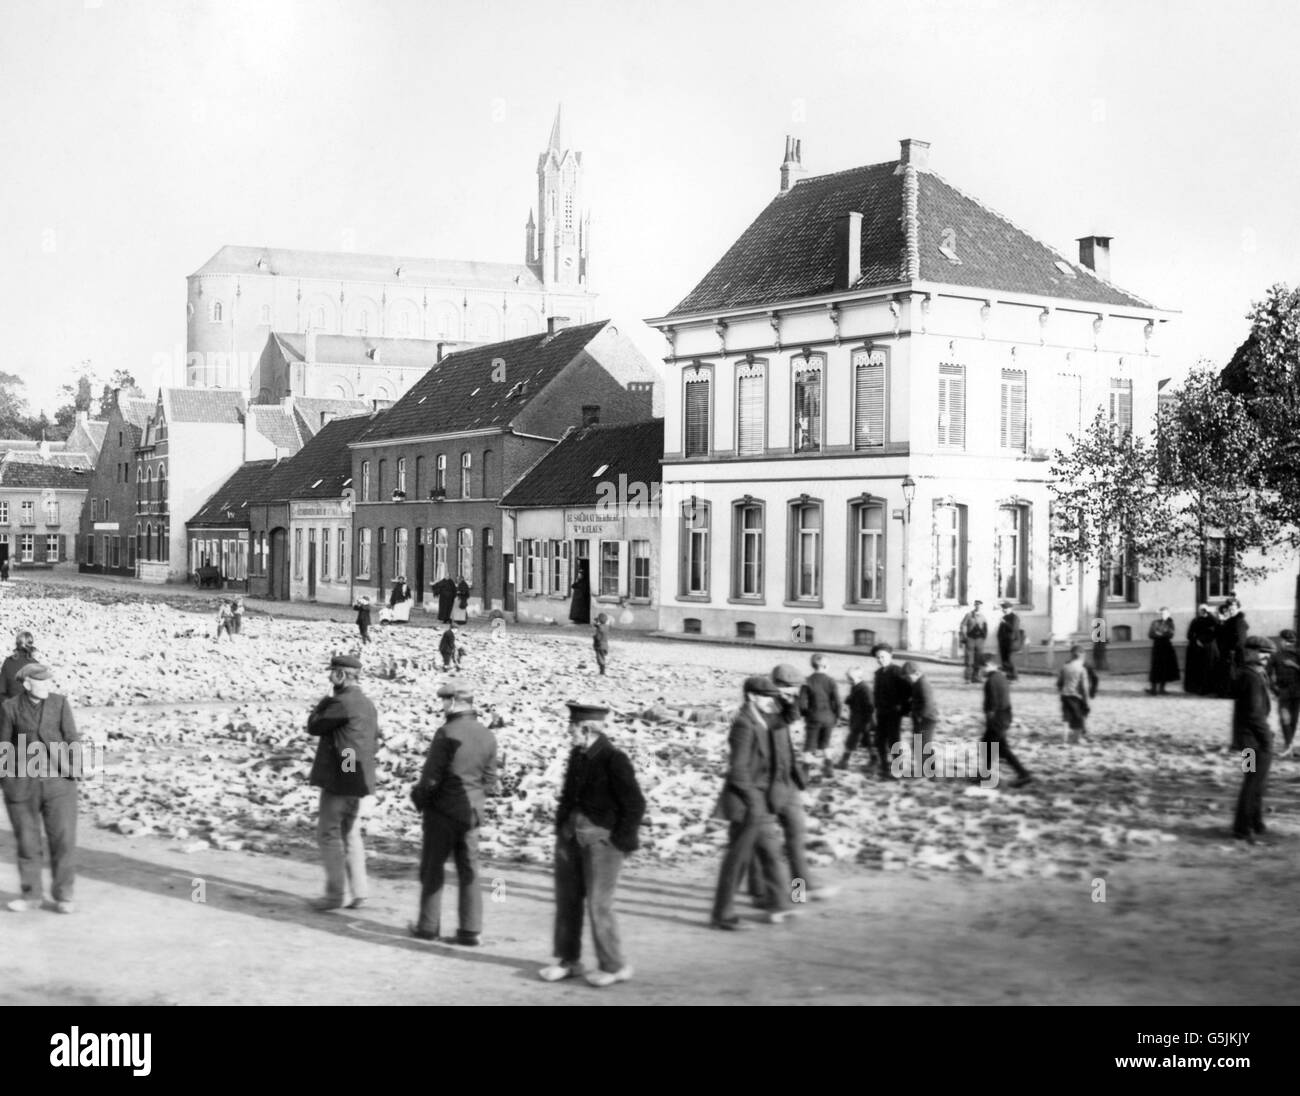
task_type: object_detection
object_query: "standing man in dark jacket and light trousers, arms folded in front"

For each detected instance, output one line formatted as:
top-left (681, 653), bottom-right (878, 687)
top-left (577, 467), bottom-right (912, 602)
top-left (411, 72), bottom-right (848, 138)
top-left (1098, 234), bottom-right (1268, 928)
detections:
top-left (307, 654), bottom-right (380, 913)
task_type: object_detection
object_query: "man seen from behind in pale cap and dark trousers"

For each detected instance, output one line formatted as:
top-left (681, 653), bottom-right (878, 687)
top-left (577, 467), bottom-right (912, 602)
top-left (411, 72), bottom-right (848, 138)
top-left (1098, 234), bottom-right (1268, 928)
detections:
top-left (410, 683), bottom-right (497, 948)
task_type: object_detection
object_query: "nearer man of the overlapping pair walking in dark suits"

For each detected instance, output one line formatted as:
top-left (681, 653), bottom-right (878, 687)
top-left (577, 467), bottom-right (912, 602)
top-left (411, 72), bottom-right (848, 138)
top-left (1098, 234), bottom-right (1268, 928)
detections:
top-left (710, 676), bottom-right (797, 931)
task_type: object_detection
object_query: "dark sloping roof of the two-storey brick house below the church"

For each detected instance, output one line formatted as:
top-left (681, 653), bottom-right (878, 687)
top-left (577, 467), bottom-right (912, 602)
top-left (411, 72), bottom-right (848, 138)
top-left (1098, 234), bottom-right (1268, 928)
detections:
top-left (358, 320), bottom-right (607, 441)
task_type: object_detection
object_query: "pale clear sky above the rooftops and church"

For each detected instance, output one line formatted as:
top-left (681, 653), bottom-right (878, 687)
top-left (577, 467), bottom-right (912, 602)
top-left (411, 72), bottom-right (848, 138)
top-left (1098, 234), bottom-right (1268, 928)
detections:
top-left (0, 0), bottom-right (1300, 413)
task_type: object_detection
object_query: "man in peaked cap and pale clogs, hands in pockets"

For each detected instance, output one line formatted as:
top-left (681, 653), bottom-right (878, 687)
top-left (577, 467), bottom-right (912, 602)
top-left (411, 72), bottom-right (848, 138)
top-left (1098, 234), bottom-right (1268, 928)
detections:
top-left (538, 701), bottom-right (646, 987)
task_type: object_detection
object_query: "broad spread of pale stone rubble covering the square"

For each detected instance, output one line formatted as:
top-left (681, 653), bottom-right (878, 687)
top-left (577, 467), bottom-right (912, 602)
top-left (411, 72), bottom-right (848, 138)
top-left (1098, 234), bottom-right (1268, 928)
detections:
top-left (4, 584), bottom-right (1238, 879)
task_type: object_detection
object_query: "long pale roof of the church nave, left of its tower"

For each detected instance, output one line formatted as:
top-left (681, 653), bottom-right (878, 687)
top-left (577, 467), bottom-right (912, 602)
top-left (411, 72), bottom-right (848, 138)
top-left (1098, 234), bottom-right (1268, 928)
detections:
top-left (191, 244), bottom-right (542, 291)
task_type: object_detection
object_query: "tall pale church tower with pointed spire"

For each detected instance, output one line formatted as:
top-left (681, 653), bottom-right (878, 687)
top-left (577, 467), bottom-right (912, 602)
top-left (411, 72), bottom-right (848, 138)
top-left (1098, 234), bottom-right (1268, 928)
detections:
top-left (525, 107), bottom-right (590, 289)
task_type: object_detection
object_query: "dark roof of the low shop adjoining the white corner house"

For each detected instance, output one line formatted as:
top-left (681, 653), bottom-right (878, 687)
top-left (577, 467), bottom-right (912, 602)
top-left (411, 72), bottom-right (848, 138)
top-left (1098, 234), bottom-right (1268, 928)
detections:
top-left (501, 419), bottom-right (663, 507)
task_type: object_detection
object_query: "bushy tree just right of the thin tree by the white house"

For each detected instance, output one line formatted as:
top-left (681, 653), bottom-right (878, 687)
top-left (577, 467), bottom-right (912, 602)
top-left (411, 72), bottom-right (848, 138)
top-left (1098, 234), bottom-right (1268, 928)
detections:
top-left (1157, 361), bottom-right (1279, 603)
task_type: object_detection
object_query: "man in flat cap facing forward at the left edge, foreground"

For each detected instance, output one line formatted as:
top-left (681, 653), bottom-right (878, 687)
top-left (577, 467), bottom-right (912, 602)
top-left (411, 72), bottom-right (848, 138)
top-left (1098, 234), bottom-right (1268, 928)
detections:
top-left (0, 662), bottom-right (79, 913)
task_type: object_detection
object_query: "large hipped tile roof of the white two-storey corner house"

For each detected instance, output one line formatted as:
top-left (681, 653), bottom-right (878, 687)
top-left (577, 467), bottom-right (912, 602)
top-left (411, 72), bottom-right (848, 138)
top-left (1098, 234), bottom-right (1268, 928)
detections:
top-left (670, 161), bottom-right (1151, 316)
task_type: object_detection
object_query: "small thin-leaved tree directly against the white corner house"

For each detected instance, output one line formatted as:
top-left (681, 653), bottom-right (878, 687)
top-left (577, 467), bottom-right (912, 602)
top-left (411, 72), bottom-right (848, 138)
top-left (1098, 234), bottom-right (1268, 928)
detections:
top-left (1049, 411), bottom-right (1177, 670)
